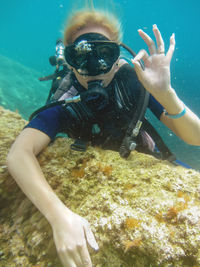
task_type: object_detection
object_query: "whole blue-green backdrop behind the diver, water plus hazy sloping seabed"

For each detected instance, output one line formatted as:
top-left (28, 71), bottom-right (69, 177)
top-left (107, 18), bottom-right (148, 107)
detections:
top-left (0, 0), bottom-right (200, 170)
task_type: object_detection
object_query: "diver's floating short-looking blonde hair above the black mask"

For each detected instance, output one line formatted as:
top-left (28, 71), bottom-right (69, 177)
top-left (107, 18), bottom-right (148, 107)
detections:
top-left (64, 8), bottom-right (122, 45)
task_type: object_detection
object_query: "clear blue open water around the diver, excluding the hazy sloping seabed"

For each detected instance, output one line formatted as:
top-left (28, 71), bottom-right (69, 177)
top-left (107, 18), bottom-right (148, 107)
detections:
top-left (0, 0), bottom-right (200, 169)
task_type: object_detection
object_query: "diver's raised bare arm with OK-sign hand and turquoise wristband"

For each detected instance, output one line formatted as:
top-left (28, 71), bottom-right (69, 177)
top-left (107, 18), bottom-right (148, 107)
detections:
top-left (132, 25), bottom-right (200, 146)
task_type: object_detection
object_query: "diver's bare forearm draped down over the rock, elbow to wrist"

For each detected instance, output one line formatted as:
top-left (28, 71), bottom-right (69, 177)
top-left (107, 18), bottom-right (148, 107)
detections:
top-left (7, 150), bottom-right (70, 224)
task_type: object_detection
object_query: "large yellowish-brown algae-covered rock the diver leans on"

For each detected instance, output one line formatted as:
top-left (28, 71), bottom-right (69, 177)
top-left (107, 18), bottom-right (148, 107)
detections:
top-left (0, 105), bottom-right (200, 267)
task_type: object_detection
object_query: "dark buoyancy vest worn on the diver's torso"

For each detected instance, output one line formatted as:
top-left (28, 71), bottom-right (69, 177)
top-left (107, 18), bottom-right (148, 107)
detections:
top-left (35, 63), bottom-right (174, 160)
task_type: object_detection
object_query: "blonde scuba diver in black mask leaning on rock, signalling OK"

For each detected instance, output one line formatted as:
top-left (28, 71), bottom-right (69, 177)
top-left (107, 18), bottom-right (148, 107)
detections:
top-left (7, 6), bottom-right (200, 267)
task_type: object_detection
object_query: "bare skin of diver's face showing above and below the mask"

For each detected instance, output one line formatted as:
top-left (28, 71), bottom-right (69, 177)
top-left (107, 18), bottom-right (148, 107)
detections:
top-left (69, 26), bottom-right (118, 89)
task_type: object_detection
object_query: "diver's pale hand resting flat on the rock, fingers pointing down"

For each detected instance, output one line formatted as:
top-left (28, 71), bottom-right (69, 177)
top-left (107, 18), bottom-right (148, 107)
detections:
top-left (52, 209), bottom-right (98, 267)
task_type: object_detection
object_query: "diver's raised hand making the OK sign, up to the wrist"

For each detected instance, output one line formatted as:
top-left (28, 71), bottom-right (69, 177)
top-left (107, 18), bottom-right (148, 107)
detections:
top-left (132, 25), bottom-right (175, 99)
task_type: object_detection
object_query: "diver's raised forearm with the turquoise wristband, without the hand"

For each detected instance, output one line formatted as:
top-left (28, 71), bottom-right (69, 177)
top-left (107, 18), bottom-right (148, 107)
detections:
top-left (158, 88), bottom-right (200, 146)
